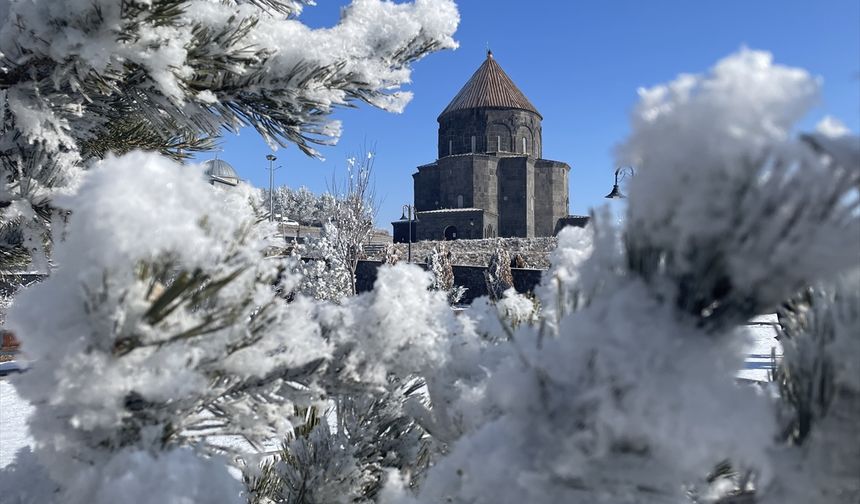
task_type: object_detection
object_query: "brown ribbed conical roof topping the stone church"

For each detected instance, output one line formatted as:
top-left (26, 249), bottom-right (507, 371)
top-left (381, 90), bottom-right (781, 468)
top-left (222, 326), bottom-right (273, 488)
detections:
top-left (439, 51), bottom-right (540, 117)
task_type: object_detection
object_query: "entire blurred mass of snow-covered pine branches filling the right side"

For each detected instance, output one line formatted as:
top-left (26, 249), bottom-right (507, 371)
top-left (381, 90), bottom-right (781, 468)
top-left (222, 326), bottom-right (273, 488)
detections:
top-left (386, 50), bottom-right (860, 504)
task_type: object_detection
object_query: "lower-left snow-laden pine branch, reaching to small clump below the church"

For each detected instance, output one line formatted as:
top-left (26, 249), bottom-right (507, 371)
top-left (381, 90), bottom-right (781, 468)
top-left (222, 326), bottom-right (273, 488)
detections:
top-left (4, 153), bottom-right (458, 503)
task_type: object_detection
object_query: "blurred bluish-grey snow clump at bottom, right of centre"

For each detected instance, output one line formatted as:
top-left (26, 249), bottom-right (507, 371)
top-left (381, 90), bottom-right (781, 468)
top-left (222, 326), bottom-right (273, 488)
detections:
top-left (412, 237), bottom-right (774, 503)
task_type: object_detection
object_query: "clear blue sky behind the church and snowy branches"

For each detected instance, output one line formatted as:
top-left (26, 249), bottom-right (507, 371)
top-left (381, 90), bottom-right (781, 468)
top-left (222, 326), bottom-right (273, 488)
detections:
top-left (198, 0), bottom-right (860, 225)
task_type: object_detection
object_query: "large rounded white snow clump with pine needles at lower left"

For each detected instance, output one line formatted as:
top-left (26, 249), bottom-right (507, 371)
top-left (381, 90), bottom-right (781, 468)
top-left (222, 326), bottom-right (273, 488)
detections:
top-left (3, 153), bottom-right (330, 502)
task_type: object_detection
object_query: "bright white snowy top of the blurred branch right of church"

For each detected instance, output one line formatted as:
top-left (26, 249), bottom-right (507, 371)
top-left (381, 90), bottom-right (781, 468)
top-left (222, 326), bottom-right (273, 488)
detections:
top-left (618, 49), bottom-right (819, 242)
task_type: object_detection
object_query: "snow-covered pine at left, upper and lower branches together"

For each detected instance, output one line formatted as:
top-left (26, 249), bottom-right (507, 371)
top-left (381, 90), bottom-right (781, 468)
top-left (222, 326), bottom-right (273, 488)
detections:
top-left (0, 0), bottom-right (457, 503)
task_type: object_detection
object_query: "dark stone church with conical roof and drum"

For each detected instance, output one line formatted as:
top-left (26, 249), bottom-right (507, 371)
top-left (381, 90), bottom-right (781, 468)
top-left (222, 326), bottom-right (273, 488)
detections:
top-left (392, 51), bottom-right (570, 242)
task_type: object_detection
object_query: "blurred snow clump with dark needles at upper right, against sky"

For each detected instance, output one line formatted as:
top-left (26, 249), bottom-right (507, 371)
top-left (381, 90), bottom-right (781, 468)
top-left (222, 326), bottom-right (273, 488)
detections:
top-left (618, 49), bottom-right (860, 318)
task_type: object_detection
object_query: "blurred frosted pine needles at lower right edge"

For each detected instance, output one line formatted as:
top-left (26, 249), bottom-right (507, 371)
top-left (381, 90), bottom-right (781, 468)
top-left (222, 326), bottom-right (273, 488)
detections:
top-left (761, 278), bottom-right (860, 504)
